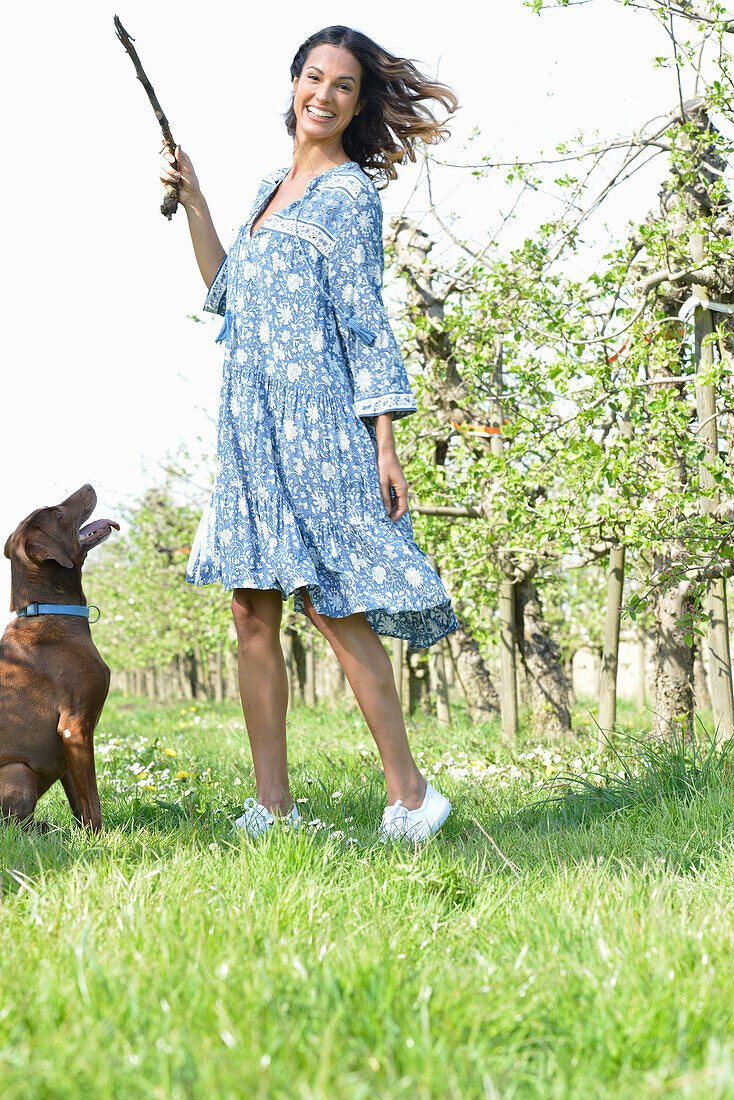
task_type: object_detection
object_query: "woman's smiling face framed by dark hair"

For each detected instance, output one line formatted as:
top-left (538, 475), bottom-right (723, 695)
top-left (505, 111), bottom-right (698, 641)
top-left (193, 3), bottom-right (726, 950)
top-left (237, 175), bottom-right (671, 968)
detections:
top-left (293, 43), bottom-right (362, 149)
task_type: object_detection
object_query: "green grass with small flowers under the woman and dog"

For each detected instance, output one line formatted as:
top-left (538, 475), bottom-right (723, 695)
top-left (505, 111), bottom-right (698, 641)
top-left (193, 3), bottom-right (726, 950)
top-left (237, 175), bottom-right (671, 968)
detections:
top-left (0, 696), bottom-right (734, 1100)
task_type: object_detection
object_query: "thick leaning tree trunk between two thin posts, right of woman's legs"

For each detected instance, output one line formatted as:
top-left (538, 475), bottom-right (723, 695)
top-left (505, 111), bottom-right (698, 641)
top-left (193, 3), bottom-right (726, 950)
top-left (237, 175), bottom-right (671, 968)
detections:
top-left (515, 579), bottom-right (571, 736)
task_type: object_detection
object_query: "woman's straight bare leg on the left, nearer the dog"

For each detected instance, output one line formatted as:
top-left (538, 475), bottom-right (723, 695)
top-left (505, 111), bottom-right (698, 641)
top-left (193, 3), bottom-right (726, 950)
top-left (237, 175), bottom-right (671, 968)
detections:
top-left (232, 589), bottom-right (293, 814)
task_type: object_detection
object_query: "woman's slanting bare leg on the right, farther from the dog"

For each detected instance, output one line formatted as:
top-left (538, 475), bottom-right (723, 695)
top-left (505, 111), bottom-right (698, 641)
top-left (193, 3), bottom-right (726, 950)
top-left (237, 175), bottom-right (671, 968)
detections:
top-left (300, 589), bottom-right (426, 810)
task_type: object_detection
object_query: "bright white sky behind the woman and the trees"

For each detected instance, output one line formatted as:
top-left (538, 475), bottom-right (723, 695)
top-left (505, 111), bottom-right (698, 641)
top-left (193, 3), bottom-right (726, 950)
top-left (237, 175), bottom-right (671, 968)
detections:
top-left (0, 0), bottom-right (691, 623)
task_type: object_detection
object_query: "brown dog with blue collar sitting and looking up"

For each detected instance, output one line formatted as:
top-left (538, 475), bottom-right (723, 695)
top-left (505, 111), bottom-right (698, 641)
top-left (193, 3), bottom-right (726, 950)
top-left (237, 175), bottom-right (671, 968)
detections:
top-left (0, 485), bottom-right (120, 832)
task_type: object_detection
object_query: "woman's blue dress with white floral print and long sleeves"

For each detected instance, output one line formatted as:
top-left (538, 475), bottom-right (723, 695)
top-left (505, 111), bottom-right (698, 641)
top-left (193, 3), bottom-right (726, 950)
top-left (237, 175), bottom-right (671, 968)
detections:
top-left (187, 161), bottom-right (459, 647)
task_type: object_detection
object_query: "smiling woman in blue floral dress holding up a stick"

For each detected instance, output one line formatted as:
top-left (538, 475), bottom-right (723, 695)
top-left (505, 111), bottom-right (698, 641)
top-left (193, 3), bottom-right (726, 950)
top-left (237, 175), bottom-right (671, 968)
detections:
top-left (161, 26), bottom-right (458, 840)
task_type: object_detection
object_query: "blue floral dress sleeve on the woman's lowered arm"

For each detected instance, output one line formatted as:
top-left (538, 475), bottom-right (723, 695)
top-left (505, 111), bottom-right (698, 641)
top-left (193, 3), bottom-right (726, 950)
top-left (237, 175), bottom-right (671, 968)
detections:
top-left (327, 191), bottom-right (417, 420)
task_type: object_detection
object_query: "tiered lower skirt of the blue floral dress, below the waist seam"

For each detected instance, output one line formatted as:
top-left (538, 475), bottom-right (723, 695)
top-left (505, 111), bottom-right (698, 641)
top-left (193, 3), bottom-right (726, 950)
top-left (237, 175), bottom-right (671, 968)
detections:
top-left (187, 358), bottom-right (458, 647)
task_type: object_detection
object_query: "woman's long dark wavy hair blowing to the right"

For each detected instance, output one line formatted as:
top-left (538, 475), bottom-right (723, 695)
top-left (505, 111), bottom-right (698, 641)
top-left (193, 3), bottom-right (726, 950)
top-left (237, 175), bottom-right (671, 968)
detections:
top-left (284, 26), bottom-right (459, 189)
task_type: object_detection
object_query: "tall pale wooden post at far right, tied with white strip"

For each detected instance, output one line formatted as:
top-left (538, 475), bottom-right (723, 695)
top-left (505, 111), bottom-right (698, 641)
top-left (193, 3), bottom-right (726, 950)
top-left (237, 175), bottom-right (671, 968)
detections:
top-left (691, 233), bottom-right (734, 745)
